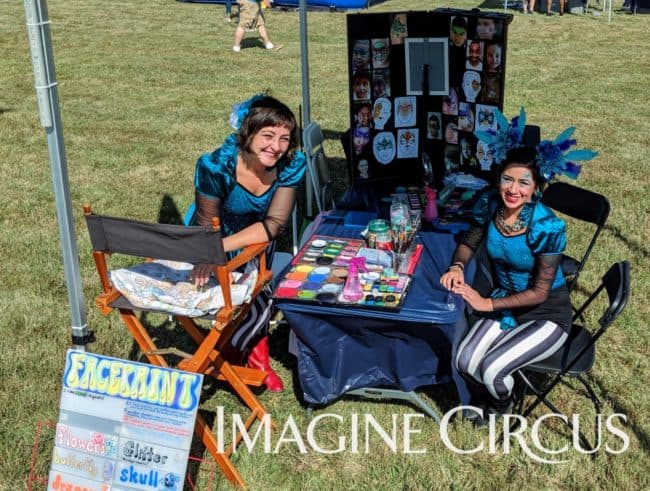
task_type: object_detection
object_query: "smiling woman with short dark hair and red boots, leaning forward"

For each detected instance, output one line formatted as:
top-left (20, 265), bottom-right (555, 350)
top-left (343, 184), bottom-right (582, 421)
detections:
top-left (190, 95), bottom-right (306, 391)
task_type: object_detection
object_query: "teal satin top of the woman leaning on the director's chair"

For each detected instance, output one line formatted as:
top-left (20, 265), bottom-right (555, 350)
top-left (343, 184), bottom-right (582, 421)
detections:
top-left (190, 134), bottom-right (306, 236)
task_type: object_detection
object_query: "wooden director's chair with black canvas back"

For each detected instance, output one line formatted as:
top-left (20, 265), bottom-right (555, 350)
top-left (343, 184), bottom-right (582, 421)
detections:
top-left (84, 205), bottom-right (272, 487)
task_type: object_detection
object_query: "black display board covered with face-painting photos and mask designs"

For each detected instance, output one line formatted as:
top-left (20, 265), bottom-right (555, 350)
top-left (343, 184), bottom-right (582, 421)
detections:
top-left (346, 9), bottom-right (512, 190)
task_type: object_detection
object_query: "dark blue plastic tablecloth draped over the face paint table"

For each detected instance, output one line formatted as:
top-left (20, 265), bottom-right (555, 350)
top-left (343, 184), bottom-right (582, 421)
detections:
top-left (276, 216), bottom-right (471, 404)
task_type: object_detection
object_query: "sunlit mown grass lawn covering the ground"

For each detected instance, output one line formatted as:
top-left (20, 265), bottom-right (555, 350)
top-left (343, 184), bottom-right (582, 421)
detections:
top-left (0, 0), bottom-right (650, 490)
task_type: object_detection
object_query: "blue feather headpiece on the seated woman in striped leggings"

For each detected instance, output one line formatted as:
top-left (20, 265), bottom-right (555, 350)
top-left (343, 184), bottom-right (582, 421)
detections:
top-left (474, 107), bottom-right (598, 182)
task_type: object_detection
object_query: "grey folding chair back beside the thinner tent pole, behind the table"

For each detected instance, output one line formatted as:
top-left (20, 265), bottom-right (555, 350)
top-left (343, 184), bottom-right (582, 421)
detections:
top-left (302, 121), bottom-right (334, 212)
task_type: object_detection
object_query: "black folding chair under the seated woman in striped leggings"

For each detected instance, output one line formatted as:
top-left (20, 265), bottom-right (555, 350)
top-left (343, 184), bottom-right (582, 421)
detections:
top-left (517, 261), bottom-right (630, 449)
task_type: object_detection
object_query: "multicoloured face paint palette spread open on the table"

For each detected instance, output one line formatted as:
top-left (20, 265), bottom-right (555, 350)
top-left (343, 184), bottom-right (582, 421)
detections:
top-left (273, 236), bottom-right (411, 309)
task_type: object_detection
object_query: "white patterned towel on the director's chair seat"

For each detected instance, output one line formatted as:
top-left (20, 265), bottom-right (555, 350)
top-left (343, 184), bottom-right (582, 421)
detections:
top-left (110, 260), bottom-right (257, 317)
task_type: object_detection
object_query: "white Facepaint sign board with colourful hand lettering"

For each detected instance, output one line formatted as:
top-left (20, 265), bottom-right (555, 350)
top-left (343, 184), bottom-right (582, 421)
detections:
top-left (47, 350), bottom-right (203, 491)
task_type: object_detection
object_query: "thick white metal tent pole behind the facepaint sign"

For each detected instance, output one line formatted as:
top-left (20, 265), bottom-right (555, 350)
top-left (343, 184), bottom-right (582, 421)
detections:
top-left (24, 0), bottom-right (92, 351)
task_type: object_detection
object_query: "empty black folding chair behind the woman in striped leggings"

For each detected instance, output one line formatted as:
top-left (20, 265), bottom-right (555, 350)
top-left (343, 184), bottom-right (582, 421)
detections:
top-left (542, 182), bottom-right (610, 290)
